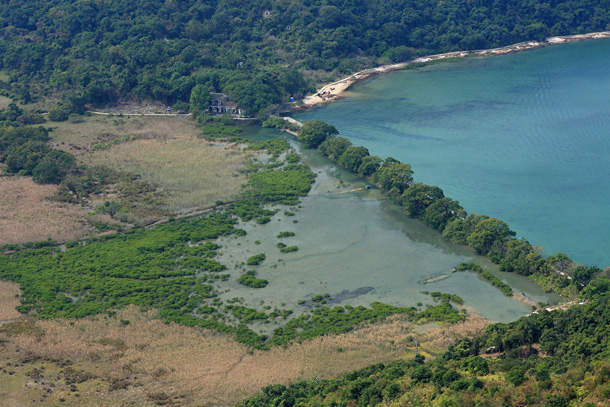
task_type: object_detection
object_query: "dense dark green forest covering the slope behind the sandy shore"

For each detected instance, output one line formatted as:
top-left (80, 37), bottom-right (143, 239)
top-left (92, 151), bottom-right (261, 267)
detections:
top-left (0, 0), bottom-right (610, 118)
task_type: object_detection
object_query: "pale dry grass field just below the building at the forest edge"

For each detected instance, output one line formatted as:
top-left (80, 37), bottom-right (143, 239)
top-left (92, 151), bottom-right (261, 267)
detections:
top-left (85, 138), bottom-right (246, 210)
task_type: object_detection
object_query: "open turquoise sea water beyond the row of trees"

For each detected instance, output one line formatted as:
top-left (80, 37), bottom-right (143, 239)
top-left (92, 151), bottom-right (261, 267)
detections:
top-left (294, 39), bottom-right (610, 266)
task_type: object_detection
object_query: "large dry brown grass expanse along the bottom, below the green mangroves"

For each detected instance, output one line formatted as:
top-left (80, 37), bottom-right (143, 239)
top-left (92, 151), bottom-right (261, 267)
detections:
top-left (0, 307), bottom-right (485, 406)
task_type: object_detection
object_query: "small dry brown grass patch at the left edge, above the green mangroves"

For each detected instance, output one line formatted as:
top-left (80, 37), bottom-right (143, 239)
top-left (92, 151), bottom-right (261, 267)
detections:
top-left (0, 176), bottom-right (90, 245)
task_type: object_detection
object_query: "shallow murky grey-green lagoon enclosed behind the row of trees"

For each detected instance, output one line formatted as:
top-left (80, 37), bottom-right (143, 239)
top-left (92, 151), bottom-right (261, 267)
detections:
top-left (215, 126), bottom-right (557, 328)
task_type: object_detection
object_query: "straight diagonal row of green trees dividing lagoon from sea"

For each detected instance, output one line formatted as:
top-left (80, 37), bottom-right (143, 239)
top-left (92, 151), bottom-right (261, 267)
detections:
top-left (298, 120), bottom-right (602, 296)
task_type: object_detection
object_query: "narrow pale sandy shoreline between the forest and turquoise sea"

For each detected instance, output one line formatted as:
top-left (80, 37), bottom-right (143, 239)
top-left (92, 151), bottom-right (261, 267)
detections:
top-left (294, 31), bottom-right (610, 110)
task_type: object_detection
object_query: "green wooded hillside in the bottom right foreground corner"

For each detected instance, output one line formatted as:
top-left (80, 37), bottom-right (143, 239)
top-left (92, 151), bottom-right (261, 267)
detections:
top-left (238, 295), bottom-right (610, 407)
